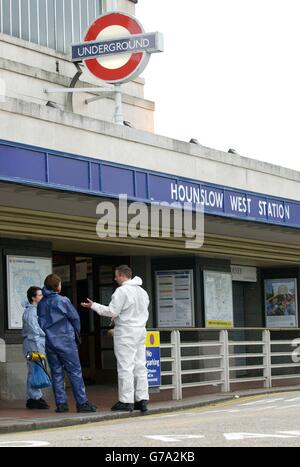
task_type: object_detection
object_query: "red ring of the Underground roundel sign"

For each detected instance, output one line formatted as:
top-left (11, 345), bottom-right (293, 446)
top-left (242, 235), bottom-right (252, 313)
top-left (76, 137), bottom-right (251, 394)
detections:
top-left (84, 13), bottom-right (143, 81)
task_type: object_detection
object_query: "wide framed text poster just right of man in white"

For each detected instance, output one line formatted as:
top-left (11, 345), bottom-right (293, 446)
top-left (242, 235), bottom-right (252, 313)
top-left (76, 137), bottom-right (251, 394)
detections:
top-left (155, 270), bottom-right (195, 328)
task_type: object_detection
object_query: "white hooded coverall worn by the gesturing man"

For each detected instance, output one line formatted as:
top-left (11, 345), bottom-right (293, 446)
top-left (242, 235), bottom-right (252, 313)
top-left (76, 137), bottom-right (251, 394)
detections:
top-left (92, 277), bottom-right (149, 404)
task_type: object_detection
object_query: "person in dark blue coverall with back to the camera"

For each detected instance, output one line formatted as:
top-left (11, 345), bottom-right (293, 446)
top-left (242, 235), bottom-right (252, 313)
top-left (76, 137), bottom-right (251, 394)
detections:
top-left (38, 274), bottom-right (96, 413)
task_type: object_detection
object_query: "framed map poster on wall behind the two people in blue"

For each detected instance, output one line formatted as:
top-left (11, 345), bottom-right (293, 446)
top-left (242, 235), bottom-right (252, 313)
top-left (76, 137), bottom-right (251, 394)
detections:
top-left (7, 256), bottom-right (52, 330)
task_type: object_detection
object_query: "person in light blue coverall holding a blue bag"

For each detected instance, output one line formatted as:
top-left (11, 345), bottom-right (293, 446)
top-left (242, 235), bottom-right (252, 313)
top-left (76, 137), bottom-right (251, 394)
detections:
top-left (22, 287), bottom-right (49, 410)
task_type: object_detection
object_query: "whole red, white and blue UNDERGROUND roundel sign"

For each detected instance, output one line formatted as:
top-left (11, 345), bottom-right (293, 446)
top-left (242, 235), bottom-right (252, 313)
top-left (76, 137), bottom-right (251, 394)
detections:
top-left (72, 12), bottom-right (163, 84)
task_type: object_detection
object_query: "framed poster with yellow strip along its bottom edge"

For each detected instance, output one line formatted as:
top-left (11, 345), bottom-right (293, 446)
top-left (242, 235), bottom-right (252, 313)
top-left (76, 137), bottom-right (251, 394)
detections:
top-left (204, 271), bottom-right (234, 328)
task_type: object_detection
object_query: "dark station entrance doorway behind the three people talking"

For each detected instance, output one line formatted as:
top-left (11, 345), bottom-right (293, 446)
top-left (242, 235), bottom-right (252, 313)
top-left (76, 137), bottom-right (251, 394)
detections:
top-left (53, 252), bottom-right (130, 384)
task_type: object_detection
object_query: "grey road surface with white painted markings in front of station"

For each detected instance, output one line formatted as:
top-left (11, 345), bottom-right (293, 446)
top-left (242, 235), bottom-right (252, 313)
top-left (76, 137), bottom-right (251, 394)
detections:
top-left (0, 390), bottom-right (300, 450)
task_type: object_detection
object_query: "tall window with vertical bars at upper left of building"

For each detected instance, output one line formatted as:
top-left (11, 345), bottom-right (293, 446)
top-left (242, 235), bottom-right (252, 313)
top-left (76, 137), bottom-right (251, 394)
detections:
top-left (0, 0), bottom-right (102, 53)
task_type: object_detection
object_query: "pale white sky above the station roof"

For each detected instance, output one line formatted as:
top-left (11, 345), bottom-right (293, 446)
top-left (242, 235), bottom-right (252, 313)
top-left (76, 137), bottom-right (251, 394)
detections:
top-left (136, 0), bottom-right (300, 170)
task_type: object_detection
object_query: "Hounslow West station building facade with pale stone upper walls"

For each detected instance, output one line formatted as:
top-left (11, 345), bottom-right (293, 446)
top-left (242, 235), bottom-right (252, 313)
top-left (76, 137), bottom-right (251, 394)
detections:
top-left (0, 0), bottom-right (300, 399)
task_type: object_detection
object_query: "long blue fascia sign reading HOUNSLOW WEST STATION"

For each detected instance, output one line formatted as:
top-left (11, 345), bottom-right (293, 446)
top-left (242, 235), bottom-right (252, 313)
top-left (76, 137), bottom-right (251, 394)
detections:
top-left (0, 141), bottom-right (300, 229)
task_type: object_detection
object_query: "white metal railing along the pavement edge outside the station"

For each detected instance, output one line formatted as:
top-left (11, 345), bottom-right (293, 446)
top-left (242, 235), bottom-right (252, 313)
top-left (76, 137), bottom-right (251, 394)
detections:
top-left (160, 328), bottom-right (300, 400)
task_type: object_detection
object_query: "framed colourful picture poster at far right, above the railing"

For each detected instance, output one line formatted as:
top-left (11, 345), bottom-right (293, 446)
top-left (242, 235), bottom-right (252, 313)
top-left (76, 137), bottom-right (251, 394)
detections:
top-left (264, 279), bottom-right (298, 328)
